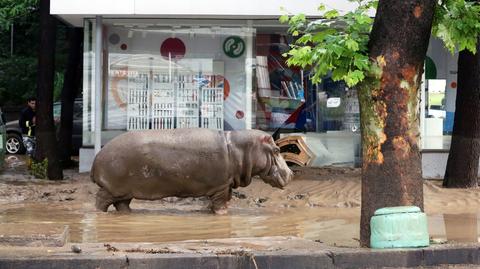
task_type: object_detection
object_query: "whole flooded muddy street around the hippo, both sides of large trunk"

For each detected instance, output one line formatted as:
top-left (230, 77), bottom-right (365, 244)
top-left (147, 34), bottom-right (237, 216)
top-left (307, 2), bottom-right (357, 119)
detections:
top-left (0, 155), bottom-right (480, 247)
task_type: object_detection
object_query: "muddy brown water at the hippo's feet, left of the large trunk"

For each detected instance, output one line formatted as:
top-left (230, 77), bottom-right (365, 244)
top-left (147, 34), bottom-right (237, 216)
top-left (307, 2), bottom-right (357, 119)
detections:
top-left (0, 203), bottom-right (359, 246)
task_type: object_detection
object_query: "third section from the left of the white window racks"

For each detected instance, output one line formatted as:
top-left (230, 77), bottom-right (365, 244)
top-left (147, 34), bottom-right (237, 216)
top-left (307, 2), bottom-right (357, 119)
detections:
top-left (174, 75), bottom-right (200, 128)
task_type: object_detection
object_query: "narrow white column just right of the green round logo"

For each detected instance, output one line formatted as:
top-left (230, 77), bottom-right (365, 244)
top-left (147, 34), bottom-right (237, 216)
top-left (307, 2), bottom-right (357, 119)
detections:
top-left (245, 20), bottom-right (254, 130)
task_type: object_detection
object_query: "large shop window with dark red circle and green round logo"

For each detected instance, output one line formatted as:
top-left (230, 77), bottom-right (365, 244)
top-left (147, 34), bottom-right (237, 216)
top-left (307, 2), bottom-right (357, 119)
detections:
top-left (96, 23), bottom-right (254, 142)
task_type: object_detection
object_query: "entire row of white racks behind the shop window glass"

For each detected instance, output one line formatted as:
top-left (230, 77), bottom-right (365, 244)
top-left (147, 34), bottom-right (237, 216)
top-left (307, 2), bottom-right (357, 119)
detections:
top-left (127, 73), bottom-right (224, 131)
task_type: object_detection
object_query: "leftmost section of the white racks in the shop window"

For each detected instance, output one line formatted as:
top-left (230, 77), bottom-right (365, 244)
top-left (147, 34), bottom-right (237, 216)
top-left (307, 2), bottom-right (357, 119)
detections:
top-left (127, 73), bottom-right (150, 131)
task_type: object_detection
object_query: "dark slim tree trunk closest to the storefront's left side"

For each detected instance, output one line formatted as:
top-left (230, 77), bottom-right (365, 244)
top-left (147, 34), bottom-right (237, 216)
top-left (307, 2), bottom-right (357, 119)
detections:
top-left (58, 28), bottom-right (83, 166)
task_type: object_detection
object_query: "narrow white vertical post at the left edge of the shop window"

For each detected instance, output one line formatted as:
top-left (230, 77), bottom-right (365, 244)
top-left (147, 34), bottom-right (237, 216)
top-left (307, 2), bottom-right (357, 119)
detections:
top-left (93, 16), bottom-right (103, 155)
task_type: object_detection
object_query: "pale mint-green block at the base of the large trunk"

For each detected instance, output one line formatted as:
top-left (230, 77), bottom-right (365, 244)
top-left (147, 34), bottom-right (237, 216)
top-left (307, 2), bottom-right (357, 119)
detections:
top-left (370, 206), bottom-right (430, 248)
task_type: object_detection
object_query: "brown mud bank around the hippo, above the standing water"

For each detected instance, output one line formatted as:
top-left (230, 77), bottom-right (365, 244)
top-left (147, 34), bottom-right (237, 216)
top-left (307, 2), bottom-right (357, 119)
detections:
top-left (0, 156), bottom-right (360, 211)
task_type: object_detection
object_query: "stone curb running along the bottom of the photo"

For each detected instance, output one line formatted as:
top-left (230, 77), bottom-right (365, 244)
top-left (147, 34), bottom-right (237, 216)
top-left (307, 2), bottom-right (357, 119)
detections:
top-left (0, 244), bottom-right (480, 269)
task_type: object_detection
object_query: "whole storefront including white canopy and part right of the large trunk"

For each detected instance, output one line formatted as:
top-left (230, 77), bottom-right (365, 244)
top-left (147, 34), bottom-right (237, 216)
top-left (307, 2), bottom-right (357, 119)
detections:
top-left (52, 0), bottom-right (462, 176)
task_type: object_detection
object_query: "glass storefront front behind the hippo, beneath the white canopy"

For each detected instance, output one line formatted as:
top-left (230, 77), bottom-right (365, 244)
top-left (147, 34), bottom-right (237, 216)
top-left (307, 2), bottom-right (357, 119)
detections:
top-left (80, 19), bottom-right (359, 170)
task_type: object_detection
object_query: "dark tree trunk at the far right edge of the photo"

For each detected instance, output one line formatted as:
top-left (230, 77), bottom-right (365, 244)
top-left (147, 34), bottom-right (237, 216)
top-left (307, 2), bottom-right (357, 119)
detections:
top-left (443, 39), bottom-right (480, 188)
